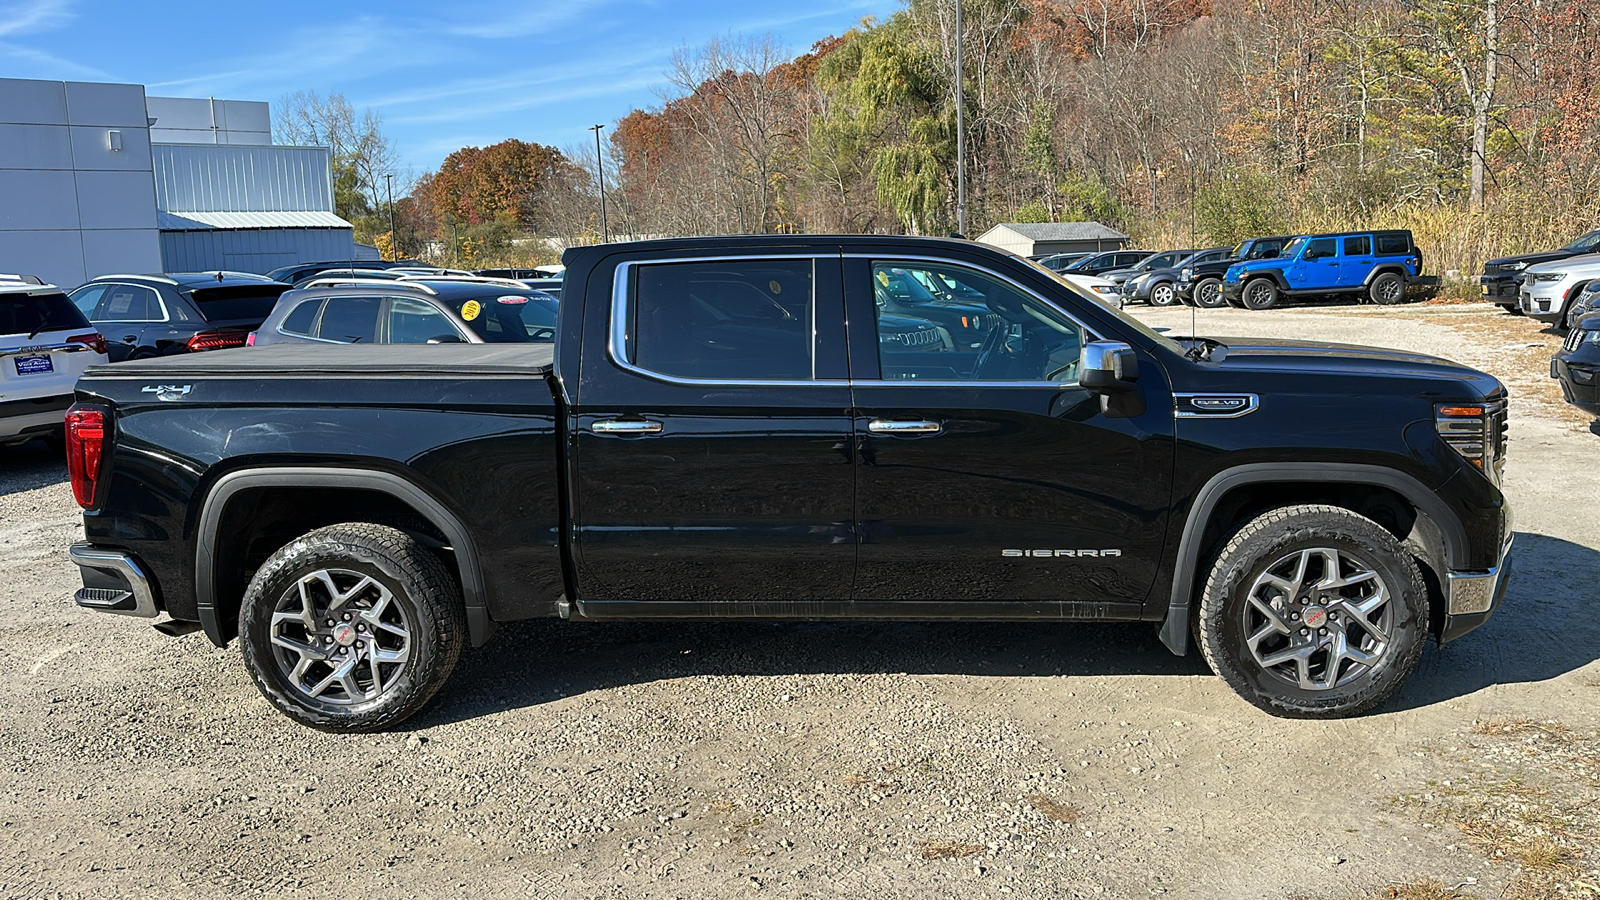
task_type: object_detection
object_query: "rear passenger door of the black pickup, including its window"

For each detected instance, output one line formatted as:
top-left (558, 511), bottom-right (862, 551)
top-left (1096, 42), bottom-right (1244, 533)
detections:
top-left (568, 248), bottom-right (872, 608)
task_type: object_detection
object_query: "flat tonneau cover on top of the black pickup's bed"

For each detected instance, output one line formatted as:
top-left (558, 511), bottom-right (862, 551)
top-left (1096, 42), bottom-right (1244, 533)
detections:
top-left (85, 344), bottom-right (555, 378)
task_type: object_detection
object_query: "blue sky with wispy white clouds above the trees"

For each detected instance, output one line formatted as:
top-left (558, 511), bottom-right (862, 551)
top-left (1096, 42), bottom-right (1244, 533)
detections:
top-left (0, 0), bottom-right (902, 175)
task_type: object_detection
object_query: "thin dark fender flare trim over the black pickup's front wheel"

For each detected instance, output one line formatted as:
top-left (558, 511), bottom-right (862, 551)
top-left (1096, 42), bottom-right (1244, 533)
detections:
top-left (1160, 463), bottom-right (1469, 657)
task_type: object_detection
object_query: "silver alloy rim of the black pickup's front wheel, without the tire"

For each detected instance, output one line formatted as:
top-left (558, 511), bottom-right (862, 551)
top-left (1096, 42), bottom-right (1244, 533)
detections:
top-left (1243, 548), bottom-right (1395, 692)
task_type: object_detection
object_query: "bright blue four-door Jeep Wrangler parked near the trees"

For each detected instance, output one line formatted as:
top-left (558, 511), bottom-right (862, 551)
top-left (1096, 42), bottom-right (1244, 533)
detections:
top-left (1222, 231), bottom-right (1430, 309)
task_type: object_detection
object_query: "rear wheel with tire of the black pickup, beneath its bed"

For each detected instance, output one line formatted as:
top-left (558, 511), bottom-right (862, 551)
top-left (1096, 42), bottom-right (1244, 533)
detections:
top-left (238, 522), bottom-right (467, 732)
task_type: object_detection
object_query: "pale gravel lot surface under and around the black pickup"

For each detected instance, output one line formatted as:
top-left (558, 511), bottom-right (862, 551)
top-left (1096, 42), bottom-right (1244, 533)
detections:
top-left (0, 299), bottom-right (1600, 898)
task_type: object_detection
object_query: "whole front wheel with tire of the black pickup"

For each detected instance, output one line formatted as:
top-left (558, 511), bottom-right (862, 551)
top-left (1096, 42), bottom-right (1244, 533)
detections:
top-left (1198, 504), bottom-right (1429, 719)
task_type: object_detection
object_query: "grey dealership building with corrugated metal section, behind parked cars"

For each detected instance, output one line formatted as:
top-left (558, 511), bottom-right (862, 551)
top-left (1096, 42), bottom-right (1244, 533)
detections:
top-left (0, 78), bottom-right (355, 287)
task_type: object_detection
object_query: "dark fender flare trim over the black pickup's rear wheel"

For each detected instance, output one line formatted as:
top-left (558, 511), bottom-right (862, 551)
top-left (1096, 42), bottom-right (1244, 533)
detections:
top-left (195, 466), bottom-right (494, 647)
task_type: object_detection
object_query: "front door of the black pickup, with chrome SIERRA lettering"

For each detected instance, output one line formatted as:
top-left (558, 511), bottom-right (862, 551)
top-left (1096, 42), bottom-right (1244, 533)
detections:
top-left (845, 258), bottom-right (1173, 608)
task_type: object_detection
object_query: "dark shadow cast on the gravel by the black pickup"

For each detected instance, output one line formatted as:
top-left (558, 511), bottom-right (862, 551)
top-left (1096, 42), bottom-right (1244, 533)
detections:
top-left (411, 533), bottom-right (1600, 727)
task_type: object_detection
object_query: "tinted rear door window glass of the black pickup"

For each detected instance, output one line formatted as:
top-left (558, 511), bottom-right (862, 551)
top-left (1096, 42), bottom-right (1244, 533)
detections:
top-left (629, 259), bottom-right (816, 381)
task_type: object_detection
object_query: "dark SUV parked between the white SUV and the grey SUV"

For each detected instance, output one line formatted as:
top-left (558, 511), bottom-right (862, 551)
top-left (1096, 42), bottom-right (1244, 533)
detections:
top-left (72, 272), bottom-right (290, 362)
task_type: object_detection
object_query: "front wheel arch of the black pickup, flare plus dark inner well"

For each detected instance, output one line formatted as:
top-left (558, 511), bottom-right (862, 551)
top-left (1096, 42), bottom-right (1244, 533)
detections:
top-left (1160, 463), bottom-right (1469, 657)
